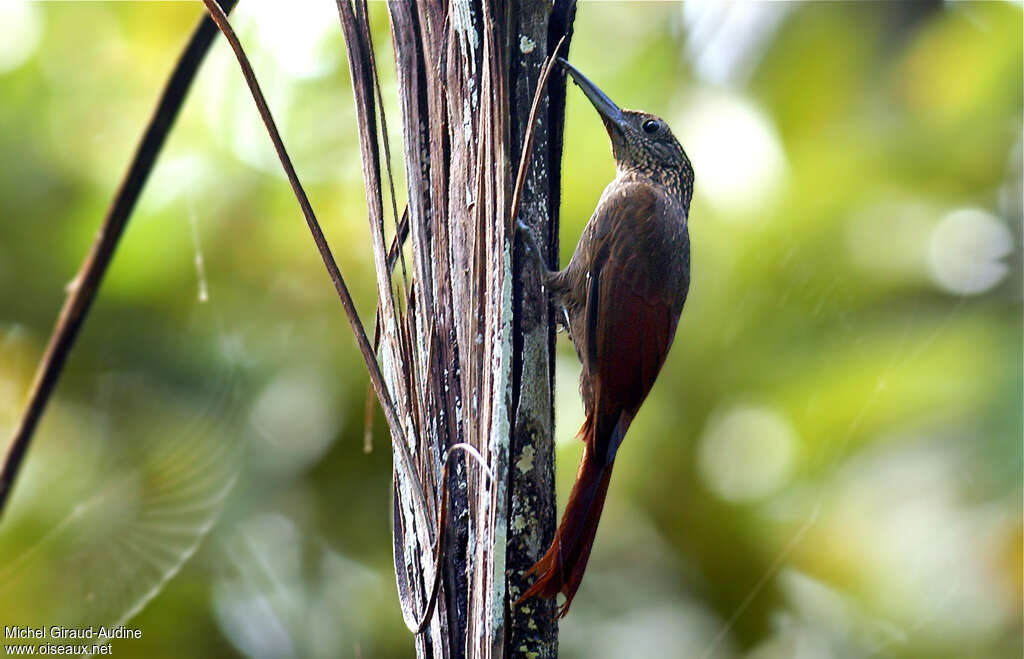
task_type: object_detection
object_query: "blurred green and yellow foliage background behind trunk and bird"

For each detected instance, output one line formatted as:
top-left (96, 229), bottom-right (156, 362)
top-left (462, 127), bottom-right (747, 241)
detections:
top-left (0, 0), bottom-right (1024, 659)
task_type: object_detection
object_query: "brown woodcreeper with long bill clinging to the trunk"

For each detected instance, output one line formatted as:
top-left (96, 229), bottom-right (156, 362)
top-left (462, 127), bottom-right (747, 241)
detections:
top-left (516, 58), bottom-right (693, 618)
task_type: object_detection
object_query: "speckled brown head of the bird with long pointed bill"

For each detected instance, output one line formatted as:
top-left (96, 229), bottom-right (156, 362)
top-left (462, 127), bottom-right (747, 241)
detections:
top-left (559, 59), bottom-right (693, 207)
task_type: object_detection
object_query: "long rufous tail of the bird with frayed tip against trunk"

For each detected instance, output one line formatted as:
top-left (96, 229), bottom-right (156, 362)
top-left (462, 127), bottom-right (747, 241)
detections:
top-left (516, 431), bottom-right (613, 618)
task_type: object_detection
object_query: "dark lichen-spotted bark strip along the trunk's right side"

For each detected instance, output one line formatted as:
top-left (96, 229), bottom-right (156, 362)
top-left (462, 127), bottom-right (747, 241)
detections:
top-left (506, 2), bottom-right (575, 658)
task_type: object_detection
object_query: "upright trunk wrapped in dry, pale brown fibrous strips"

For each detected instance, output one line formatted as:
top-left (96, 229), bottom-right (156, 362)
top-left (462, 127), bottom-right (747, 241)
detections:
top-left (339, 0), bottom-right (574, 657)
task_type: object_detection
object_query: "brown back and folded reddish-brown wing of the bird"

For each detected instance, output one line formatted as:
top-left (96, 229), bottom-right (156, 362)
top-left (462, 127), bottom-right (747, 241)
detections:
top-left (586, 184), bottom-right (689, 459)
